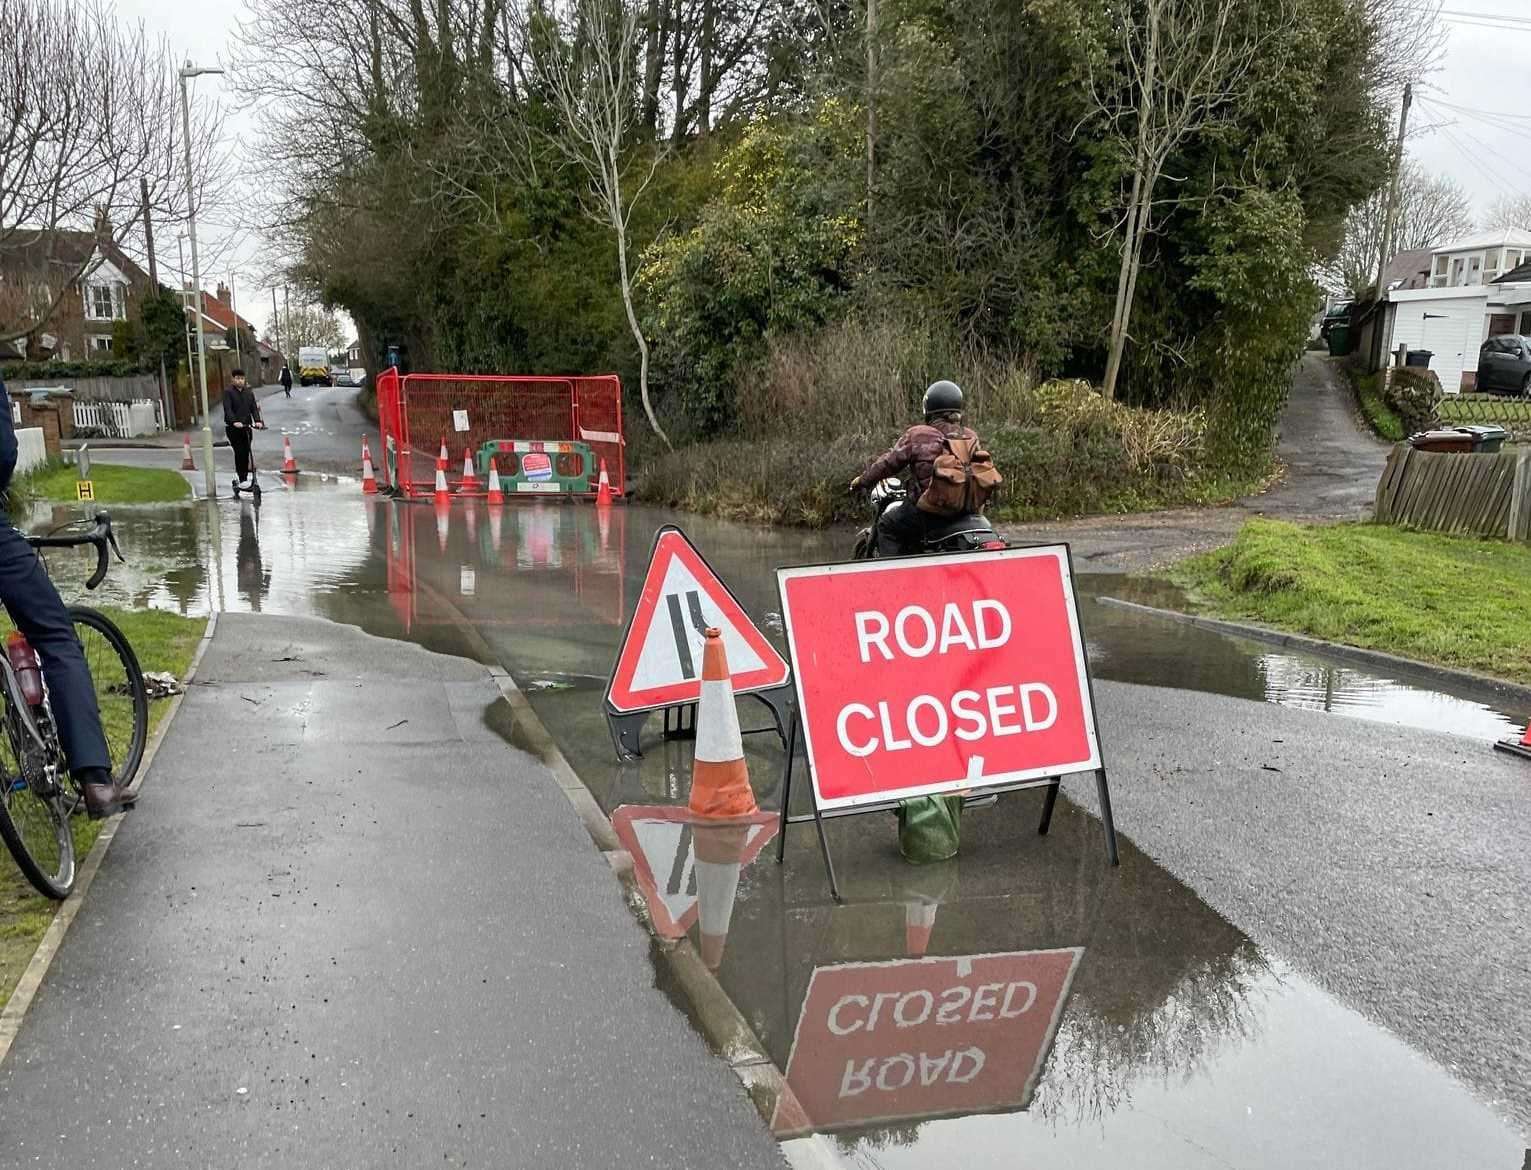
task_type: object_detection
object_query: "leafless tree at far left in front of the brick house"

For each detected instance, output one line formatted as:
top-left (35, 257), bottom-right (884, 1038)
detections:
top-left (0, 0), bottom-right (219, 343)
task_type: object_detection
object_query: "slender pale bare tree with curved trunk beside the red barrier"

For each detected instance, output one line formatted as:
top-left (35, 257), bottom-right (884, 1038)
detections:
top-left (531, 0), bottom-right (672, 447)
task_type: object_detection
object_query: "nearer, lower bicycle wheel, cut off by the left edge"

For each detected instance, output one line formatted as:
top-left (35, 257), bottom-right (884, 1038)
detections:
top-left (0, 697), bottom-right (75, 899)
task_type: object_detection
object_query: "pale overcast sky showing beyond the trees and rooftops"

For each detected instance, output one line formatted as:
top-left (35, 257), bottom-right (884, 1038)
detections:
top-left (116, 0), bottom-right (1531, 339)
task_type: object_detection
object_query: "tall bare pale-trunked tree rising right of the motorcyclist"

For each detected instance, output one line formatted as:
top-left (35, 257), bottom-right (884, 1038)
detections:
top-left (1090, 0), bottom-right (1291, 398)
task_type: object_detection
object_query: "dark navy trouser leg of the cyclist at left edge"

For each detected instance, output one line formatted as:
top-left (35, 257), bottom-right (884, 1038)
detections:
top-left (0, 515), bottom-right (112, 775)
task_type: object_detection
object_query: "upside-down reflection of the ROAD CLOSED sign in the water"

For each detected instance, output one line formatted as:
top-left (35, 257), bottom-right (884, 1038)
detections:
top-left (773, 946), bottom-right (1084, 1136)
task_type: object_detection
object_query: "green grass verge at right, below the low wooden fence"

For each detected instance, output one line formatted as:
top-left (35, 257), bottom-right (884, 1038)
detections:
top-left (1162, 521), bottom-right (1531, 683)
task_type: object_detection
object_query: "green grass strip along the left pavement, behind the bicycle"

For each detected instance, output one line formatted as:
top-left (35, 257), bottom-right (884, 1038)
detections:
top-left (0, 610), bottom-right (207, 1008)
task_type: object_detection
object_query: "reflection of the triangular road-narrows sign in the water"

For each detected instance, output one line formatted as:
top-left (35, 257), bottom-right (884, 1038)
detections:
top-left (611, 804), bottom-right (781, 939)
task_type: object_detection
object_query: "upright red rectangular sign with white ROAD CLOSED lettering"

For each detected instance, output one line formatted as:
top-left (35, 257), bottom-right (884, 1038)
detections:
top-left (776, 545), bottom-right (1101, 809)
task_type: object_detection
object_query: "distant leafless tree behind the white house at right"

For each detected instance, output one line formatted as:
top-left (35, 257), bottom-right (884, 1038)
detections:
top-left (1324, 159), bottom-right (1475, 297)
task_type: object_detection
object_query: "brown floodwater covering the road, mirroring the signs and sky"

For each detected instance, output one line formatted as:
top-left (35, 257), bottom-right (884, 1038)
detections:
top-left (34, 481), bottom-right (1525, 1170)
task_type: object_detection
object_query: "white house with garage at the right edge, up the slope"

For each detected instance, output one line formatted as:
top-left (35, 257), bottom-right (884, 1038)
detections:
top-left (1370, 231), bottom-right (1531, 394)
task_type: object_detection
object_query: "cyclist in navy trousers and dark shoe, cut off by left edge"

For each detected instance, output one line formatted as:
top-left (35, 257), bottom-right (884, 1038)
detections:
top-left (0, 380), bottom-right (126, 819)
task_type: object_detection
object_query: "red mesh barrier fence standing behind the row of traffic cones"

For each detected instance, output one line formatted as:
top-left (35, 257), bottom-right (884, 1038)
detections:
top-left (377, 369), bottom-right (626, 498)
